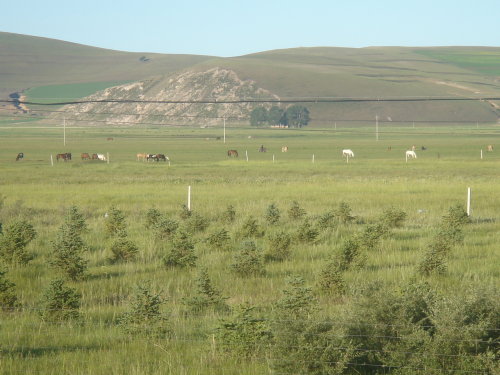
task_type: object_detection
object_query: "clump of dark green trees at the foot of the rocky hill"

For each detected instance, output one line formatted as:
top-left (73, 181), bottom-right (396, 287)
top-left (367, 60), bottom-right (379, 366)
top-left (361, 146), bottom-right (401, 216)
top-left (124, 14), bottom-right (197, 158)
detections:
top-left (250, 104), bottom-right (310, 128)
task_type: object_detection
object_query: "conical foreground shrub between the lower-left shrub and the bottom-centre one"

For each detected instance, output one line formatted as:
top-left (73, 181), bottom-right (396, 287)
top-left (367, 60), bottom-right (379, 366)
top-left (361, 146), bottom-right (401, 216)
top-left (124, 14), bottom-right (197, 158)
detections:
top-left (118, 282), bottom-right (171, 338)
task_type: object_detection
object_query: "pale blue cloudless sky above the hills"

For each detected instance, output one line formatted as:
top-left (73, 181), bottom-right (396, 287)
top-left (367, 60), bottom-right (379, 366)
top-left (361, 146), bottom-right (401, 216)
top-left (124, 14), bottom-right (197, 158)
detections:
top-left (0, 0), bottom-right (500, 57)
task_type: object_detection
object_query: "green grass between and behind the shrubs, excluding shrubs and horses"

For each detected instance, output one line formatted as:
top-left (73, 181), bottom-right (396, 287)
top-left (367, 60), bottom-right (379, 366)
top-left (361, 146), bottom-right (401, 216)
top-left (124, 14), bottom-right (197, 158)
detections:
top-left (0, 123), bottom-right (500, 374)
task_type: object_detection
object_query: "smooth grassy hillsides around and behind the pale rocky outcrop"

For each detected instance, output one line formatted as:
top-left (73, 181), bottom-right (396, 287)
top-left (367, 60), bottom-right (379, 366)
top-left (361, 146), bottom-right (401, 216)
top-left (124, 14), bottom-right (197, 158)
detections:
top-left (0, 33), bottom-right (500, 126)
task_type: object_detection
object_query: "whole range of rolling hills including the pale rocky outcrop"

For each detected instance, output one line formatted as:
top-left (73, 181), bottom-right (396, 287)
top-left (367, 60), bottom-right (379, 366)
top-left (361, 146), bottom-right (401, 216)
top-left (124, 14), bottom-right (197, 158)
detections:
top-left (0, 33), bottom-right (500, 126)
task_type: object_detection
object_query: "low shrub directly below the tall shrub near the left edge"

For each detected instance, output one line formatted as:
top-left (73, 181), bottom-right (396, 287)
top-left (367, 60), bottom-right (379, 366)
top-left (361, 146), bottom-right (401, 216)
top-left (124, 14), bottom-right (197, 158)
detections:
top-left (40, 279), bottom-right (82, 323)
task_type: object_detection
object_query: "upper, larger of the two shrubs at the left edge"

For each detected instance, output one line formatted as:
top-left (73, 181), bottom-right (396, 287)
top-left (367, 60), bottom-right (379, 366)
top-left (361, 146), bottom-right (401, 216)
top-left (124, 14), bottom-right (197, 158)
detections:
top-left (0, 220), bottom-right (37, 264)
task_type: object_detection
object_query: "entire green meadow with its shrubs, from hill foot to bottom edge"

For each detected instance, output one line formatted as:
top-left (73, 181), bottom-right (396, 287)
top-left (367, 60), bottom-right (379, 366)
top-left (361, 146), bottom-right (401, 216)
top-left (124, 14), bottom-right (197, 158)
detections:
top-left (0, 120), bottom-right (500, 375)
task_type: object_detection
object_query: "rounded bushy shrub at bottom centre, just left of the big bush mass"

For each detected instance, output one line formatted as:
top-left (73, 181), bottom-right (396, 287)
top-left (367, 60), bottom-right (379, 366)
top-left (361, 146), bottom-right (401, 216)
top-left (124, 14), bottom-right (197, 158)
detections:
top-left (216, 304), bottom-right (272, 359)
